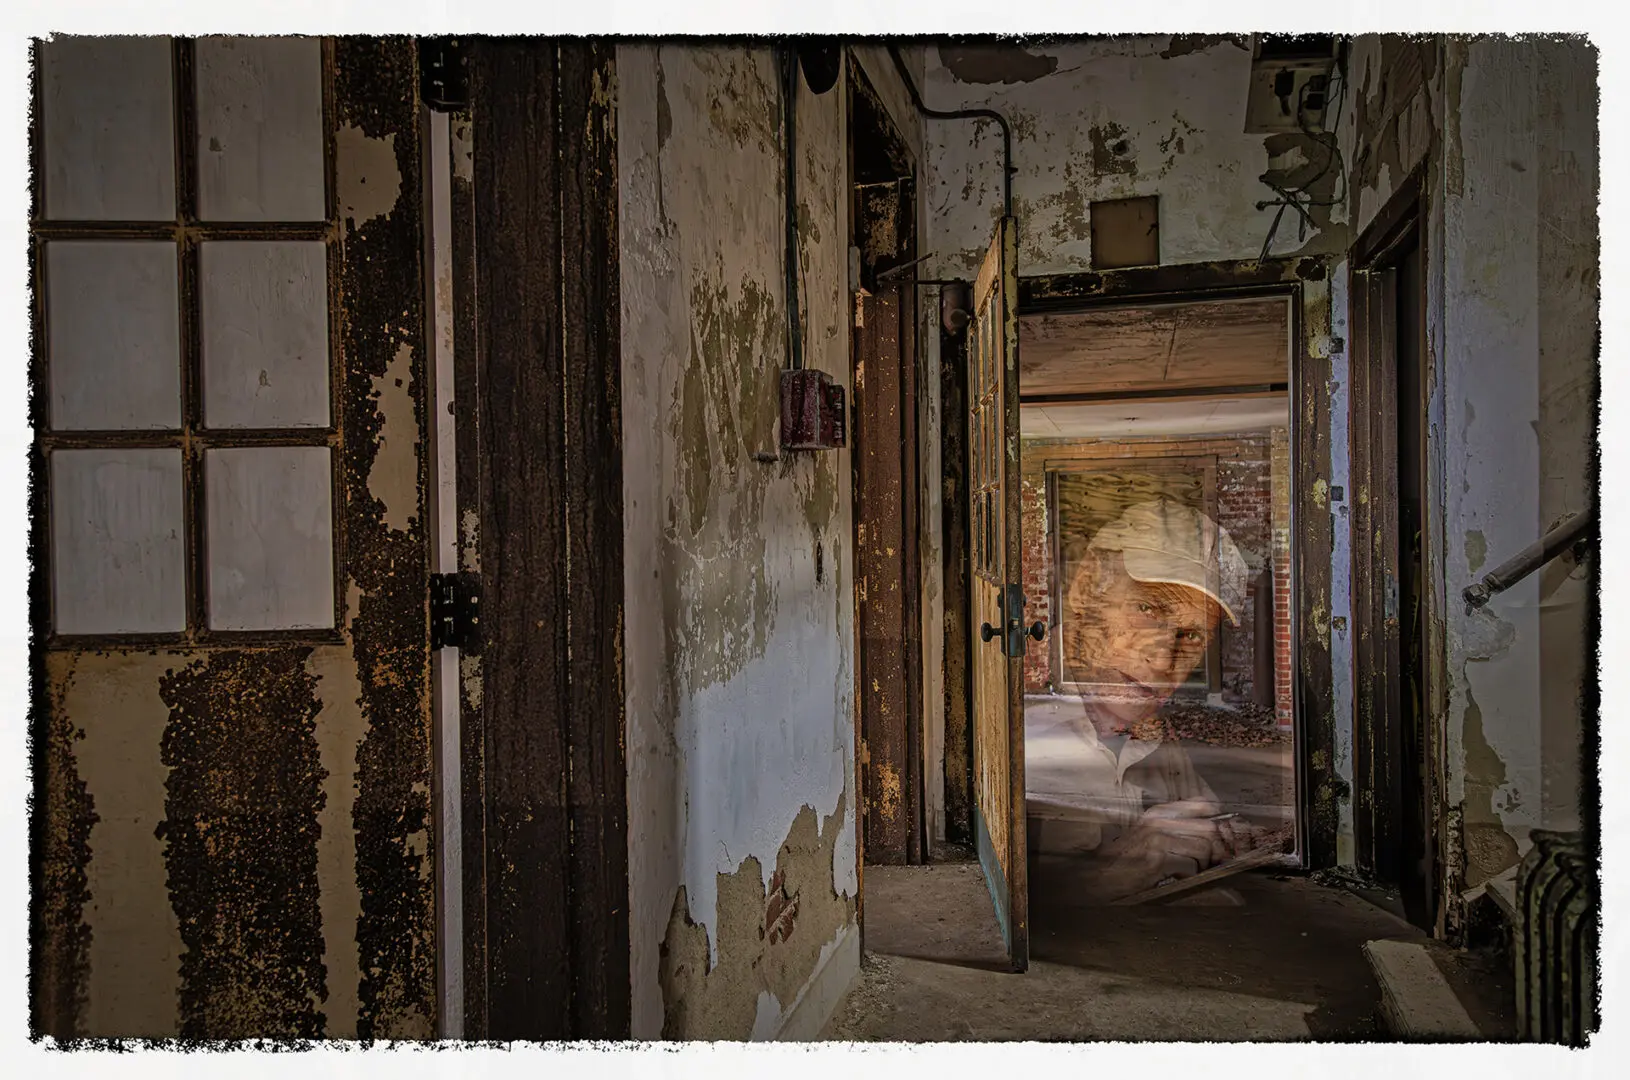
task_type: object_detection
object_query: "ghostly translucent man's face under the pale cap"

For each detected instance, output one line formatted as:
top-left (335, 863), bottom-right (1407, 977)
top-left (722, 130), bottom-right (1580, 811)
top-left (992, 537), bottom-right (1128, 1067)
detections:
top-left (1068, 555), bottom-right (1218, 722)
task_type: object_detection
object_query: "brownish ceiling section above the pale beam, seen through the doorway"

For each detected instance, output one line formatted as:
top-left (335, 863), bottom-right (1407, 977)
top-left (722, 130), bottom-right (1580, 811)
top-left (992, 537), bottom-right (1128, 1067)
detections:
top-left (1019, 296), bottom-right (1289, 397)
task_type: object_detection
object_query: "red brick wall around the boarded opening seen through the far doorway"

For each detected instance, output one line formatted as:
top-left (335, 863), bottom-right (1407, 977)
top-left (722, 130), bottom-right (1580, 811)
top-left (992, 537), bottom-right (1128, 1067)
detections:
top-left (1020, 432), bottom-right (1289, 700)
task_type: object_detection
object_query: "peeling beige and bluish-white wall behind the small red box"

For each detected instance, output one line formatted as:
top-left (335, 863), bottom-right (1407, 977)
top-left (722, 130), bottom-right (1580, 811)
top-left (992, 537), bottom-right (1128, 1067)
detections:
top-left (618, 44), bottom-right (914, 1039)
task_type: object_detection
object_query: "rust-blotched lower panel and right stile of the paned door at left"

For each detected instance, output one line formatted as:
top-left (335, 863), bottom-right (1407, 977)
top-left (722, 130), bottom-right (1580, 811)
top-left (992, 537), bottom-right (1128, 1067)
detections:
top-left (33, 37), bottom-right (435, 1039)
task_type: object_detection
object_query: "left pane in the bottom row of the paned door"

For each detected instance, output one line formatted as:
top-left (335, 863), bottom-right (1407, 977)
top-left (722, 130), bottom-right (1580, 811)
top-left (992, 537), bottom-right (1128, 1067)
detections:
top-left (51, 450), bottom-right (186, 634)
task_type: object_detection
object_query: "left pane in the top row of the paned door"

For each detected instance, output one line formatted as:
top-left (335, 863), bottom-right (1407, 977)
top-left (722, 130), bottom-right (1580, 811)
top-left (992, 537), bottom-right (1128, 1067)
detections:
top-left (39, 36), bottom-right (176, 222)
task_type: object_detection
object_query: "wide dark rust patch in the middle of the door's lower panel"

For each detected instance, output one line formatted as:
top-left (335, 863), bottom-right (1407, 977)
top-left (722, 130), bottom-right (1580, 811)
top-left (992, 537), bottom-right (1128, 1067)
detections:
top-left (156, 647), bottom-right (328, 1039)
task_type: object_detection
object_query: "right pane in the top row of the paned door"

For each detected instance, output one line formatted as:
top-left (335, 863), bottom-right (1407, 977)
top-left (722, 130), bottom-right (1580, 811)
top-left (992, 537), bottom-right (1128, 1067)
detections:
top-left (196, 37), bottom-right (328, 222)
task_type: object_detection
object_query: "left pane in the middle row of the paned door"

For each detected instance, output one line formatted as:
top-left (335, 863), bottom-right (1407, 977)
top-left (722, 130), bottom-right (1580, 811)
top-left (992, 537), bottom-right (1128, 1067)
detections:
top-left (46, 241), bottom-right (181, 432)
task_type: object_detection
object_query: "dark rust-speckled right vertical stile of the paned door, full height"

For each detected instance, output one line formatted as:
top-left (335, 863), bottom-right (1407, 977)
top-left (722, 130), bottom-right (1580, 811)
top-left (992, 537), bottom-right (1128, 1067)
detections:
top-left (331, 37), bottom-right (435, 1038)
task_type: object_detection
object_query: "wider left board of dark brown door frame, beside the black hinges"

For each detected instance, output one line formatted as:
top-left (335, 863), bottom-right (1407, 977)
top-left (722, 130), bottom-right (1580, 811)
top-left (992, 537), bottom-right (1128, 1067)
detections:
top-left (469, 37), bottom-right (572, 1039)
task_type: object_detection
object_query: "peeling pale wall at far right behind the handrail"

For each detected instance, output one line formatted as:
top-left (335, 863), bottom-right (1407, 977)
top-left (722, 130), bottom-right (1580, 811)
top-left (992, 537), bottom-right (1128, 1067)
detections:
top-left (1430, 37), bottom-right (1601, 886)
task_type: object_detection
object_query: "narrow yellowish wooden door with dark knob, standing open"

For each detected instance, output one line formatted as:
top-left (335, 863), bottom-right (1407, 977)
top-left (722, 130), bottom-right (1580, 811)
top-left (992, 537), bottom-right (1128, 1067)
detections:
top-left (968, 217), bottom-right (1042, 971)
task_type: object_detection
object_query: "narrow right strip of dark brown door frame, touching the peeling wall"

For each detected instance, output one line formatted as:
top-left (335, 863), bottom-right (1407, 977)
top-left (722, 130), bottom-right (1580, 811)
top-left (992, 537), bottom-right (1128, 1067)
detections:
top-left (557, 39), bottom-right (632, 1039)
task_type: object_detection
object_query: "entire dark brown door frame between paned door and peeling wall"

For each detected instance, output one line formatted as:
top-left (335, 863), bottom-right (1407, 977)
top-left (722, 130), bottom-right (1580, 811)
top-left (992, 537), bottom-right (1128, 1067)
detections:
top-left (453, 37), bottom-right (632, 1039)
